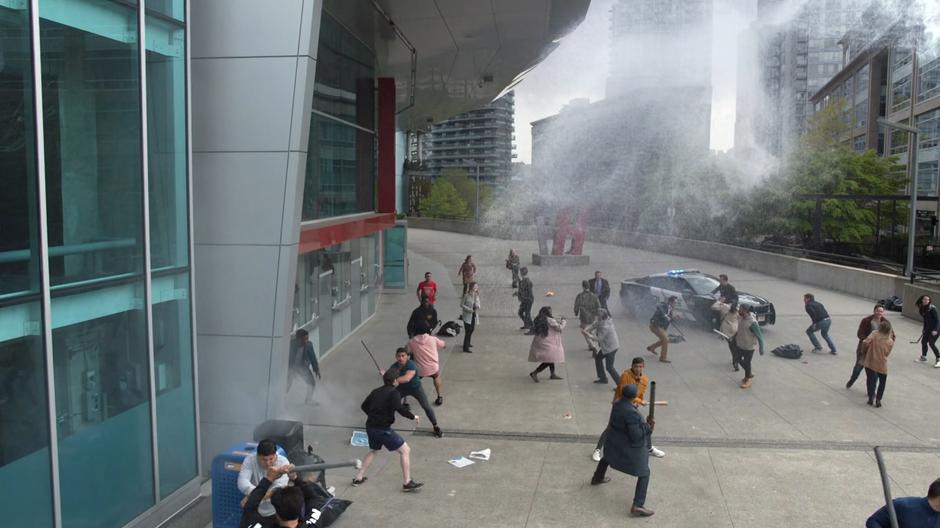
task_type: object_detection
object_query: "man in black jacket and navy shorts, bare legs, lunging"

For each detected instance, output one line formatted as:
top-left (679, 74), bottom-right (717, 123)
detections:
top-left (352, 367), bottom-right (424, 491)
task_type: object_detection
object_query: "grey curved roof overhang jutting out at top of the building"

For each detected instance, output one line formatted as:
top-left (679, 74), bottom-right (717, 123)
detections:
top-left (328, 0), bottom-right (591, 130)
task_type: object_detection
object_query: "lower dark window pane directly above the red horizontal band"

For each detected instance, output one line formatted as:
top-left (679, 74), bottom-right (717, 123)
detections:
top-left (302, 113), bottom-right (375, 220)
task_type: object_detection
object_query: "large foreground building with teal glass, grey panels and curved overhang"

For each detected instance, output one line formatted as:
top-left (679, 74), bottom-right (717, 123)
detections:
top-left (0, 0), bottom-right (589, 528)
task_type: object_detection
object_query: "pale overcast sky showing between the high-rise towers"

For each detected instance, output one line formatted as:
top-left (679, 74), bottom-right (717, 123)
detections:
top-left (516, 0), bottom-right (756, 163)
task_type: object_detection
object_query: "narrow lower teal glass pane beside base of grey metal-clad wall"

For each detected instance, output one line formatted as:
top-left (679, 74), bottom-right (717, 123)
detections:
top-left (151, 273), bottom-right (197, 498)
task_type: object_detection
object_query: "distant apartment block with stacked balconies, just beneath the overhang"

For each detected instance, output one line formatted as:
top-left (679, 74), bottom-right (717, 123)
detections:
top-left (423, 91), bottom-right (516, 184)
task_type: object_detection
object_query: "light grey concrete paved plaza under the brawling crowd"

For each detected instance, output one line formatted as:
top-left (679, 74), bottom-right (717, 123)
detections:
top-left (195, 229), bottom-right (940, 528)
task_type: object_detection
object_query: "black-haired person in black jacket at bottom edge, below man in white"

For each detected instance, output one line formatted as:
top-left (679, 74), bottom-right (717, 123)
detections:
top-left (239, 464), bottom-right (322, 528)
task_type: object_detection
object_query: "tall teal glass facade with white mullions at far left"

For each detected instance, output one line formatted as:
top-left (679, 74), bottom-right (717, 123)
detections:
top-left (0, 0), bottom-right (198, 527)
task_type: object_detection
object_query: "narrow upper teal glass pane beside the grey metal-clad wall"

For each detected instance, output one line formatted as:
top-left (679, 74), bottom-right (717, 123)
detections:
top-left (147, 15), bottom-right (189, 271)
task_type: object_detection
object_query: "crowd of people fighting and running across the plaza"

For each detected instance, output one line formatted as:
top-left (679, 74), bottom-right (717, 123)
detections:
top-left (274, 250), bottom-right (940, 527)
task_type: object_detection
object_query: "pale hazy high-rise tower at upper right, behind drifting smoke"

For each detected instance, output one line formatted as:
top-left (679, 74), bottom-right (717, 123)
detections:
top-left (735, 0), bottom-right (865, 155)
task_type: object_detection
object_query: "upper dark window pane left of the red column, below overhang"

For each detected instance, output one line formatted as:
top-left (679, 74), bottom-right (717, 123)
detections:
top-left (313, 12), bottom-right (375, 130)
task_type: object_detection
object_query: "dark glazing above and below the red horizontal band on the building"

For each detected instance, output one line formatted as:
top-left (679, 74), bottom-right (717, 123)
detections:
top-left (293, 10), bottom-right (382, 366)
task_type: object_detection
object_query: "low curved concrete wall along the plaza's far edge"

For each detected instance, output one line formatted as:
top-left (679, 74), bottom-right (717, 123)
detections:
top-left (408, 218), bottom-right (912, 304)
